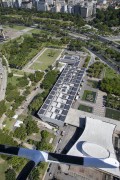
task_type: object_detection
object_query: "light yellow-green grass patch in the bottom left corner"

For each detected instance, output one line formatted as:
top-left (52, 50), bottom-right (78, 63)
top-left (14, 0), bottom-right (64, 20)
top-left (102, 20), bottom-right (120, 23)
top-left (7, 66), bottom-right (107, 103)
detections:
top-left (0, 159), bottom-right (8, 180)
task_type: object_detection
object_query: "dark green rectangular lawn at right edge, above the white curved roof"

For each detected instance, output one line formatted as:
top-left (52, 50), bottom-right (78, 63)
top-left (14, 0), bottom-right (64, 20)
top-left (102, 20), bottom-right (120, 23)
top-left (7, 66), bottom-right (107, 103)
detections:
top-left (105, 108), bottom-right (120, 121)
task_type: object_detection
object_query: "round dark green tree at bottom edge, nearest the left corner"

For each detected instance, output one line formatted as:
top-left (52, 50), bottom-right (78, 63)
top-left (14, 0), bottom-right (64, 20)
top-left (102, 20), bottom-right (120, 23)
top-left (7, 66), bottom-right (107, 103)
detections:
top-left (5, 169), bottom-right (16, 180)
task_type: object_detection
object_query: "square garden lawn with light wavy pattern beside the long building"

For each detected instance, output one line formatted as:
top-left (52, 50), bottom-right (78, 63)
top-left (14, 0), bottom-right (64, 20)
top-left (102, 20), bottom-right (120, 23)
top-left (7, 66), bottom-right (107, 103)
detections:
top-left (82, 90), bottom-right (96, 103)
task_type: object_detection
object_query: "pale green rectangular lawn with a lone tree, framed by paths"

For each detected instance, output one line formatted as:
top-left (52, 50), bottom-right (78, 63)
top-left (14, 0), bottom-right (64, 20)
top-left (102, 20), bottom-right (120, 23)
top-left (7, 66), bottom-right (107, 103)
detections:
top-left (30, 49), bottom-right (61, 71)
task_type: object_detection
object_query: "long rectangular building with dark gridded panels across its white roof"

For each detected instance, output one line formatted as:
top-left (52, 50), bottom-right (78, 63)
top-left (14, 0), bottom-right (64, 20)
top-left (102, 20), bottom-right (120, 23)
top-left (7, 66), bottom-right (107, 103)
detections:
top-left (38, 60), bottom-right (85, 126)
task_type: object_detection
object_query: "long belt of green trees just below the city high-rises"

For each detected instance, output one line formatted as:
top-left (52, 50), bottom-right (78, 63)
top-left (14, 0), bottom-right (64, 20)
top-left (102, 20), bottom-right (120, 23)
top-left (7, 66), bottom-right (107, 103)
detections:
top-left (0, 7), bottom-right (85, 28)
